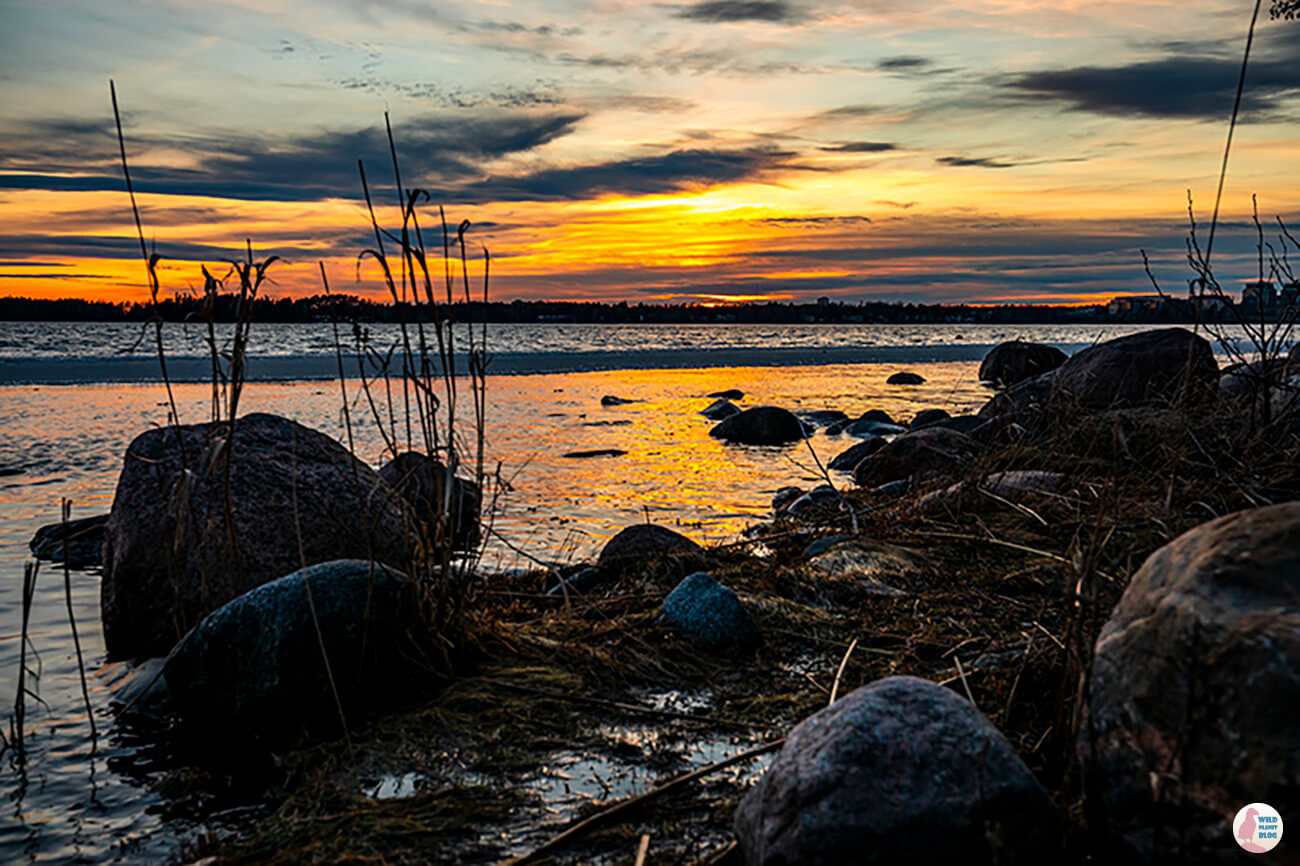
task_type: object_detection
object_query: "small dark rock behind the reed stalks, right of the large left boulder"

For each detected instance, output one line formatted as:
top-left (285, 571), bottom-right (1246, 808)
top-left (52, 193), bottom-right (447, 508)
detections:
top-left (380, 451), bottom-right (484, 550)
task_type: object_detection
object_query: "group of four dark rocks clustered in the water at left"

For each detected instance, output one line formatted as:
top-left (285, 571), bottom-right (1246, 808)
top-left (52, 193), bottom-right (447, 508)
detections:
top-left (41, 413), bottom-right (482, 739)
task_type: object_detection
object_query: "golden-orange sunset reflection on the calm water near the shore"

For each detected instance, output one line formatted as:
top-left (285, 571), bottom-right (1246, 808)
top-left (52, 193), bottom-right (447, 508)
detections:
top-left (0, 363), bottom-right (988, 567)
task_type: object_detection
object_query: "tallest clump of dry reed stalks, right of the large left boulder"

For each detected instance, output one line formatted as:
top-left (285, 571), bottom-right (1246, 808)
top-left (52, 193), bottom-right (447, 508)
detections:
top-left (321, 114), bottom-right (497, 674)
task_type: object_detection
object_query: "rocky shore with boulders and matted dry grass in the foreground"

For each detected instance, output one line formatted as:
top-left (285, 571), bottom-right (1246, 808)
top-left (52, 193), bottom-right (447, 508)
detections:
top-left (34, 328), bottom-right (1300, 866)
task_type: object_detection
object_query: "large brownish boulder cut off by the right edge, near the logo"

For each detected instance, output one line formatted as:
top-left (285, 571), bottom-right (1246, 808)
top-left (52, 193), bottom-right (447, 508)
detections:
top-left (1079, 502), bottom-right (1300, 863)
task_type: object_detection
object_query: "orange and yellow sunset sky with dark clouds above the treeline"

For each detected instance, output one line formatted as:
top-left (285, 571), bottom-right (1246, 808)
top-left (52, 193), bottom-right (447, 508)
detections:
top-left (0, 0), bottom-right (1300, 302)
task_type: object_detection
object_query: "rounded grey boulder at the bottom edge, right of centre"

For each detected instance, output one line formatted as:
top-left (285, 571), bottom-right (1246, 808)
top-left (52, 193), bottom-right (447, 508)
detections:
top-left (736, 676), bottom-right (1060, 866)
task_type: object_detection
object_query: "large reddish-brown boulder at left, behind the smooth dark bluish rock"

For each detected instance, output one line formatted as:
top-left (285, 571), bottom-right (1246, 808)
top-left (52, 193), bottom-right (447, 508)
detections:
top-left (100, 415), bottom-right (412, 658)
